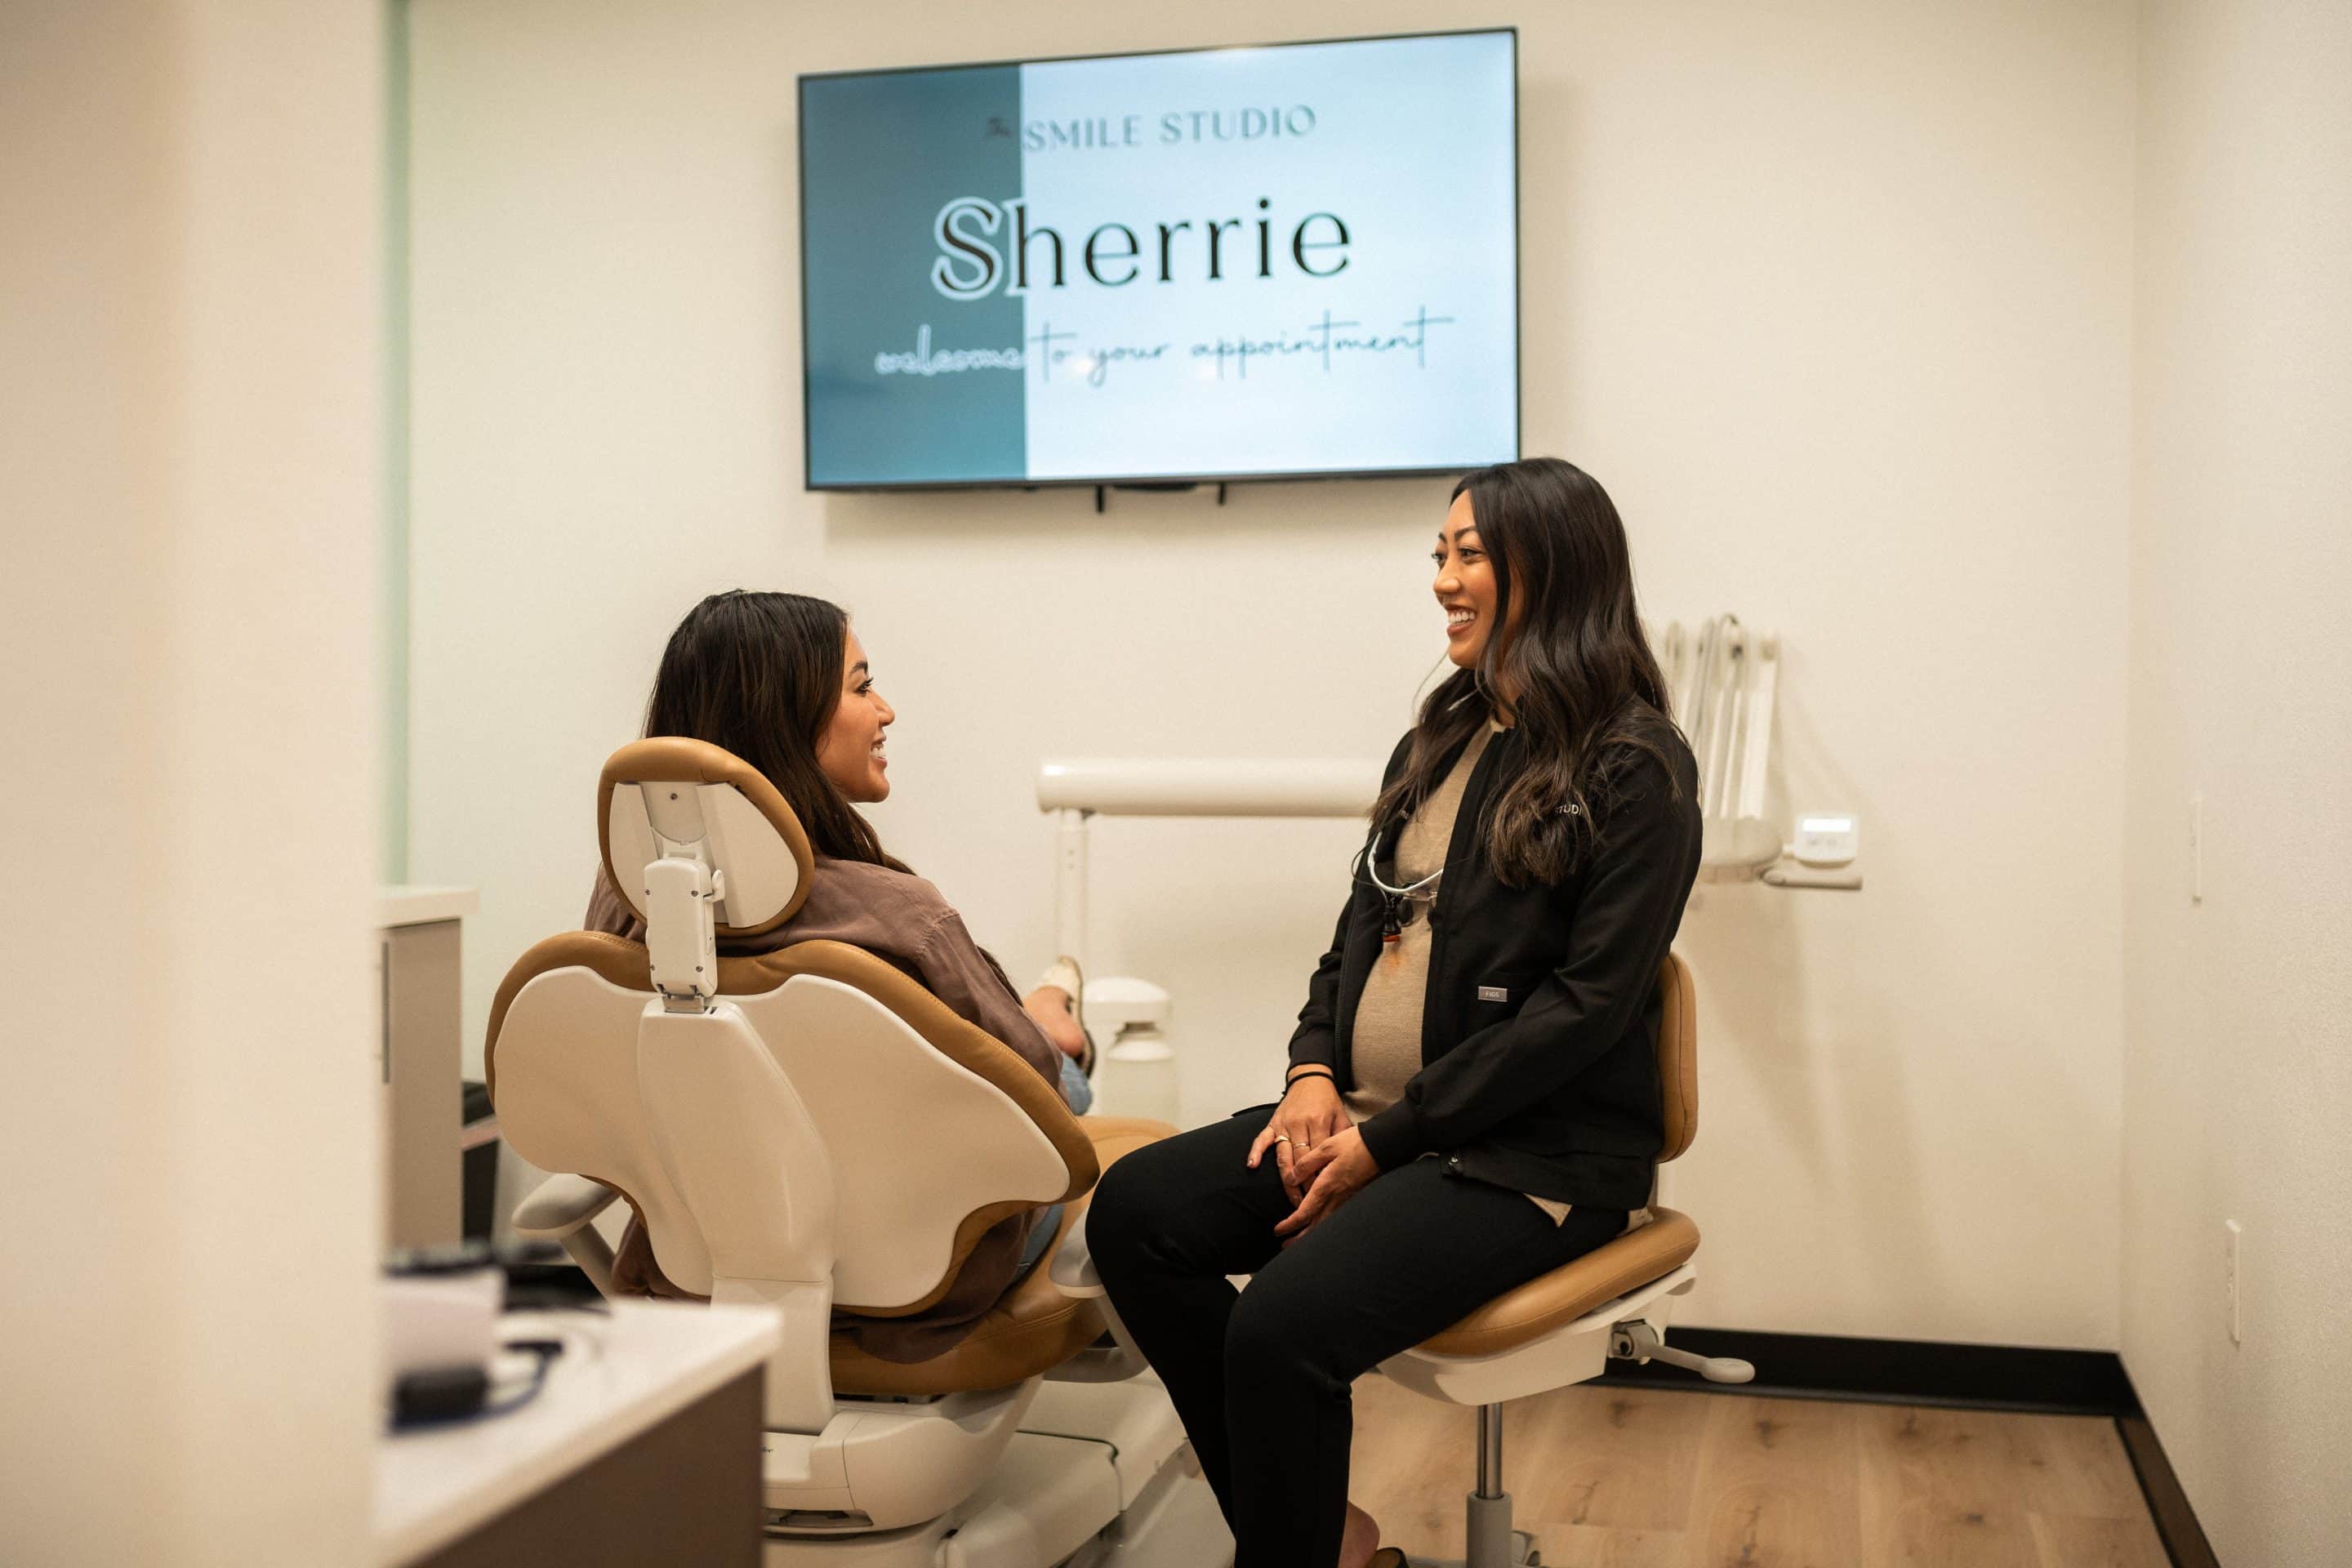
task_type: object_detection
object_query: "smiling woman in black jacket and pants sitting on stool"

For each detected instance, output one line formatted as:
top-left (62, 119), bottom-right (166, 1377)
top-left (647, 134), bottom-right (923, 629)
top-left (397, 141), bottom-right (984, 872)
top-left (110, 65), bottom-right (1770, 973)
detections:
top-left (1087, 458), bottom-right (1698, 1568)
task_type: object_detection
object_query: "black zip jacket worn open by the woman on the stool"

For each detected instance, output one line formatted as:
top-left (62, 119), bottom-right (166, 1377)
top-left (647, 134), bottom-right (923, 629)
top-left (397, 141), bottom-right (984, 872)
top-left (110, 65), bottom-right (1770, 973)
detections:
top-left (1291, 710), bottom-right (1698, 1209)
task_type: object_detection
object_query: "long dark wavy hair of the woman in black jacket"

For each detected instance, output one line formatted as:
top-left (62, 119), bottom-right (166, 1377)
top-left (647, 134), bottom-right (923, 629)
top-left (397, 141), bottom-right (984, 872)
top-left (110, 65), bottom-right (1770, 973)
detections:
top-left (1371, 458), bottom-right (1679, 886)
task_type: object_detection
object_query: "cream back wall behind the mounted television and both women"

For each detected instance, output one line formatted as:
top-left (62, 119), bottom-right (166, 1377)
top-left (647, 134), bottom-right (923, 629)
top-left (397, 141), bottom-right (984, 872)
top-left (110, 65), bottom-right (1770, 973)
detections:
top-left (412, 0), bottom-right (2133, 1347)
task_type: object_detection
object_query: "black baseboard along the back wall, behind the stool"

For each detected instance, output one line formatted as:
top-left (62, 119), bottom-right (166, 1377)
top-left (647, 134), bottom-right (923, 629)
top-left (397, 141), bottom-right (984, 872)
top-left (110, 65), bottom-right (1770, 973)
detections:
top-left (1597, 1328), bottom-right (2140, 1418)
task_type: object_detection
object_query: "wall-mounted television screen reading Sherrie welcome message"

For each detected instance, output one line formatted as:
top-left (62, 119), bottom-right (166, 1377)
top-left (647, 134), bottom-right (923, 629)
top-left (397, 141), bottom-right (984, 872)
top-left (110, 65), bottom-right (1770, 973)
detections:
top-left (800, 29), bottom-right (1519, 489)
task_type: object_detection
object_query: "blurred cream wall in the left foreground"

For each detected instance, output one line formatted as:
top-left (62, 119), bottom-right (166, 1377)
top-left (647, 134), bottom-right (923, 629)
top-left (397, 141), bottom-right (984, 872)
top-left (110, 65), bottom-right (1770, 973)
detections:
top-left (0, 0), bottom-right (381, 1568)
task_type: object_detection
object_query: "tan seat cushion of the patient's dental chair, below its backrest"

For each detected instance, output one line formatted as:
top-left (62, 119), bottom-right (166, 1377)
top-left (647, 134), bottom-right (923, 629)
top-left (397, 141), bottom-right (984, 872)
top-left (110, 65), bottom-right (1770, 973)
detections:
top-left (831, 1116), bottom-right (1176, 1394)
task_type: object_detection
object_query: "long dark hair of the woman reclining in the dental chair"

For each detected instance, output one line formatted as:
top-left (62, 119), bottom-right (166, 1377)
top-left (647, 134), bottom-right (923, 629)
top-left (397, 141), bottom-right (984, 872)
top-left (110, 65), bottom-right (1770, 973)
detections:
top-left (644, 588), bottom-right (906, 872)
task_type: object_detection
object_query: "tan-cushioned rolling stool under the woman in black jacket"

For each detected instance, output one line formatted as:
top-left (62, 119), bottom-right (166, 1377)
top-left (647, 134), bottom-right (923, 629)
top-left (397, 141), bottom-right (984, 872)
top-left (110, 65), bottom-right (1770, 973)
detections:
top-left (1381, 952), bottom-right (1754, 1568)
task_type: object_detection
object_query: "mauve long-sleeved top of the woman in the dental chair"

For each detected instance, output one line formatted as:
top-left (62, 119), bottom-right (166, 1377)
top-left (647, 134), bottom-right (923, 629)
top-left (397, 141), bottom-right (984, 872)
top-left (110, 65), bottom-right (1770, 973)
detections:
top-left (586, 856), bottom-right (1061, 1361)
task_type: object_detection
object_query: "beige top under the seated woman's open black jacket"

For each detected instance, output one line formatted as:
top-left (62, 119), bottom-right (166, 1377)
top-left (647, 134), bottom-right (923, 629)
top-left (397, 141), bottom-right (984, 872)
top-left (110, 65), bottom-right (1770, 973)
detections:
top-left (1341, 719), bottom-right (1569, 1223)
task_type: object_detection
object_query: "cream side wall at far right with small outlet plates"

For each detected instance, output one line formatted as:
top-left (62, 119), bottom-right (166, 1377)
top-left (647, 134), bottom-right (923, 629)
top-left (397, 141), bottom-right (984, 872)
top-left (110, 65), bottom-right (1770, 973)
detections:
top-left (2122, 0), bottom-right (2352, 1566)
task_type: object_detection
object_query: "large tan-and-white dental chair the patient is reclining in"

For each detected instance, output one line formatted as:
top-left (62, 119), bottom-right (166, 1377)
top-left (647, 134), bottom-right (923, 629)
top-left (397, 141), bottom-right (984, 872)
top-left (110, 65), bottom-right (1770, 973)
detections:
top-left (487, 738), bottom-right (1232, 1568)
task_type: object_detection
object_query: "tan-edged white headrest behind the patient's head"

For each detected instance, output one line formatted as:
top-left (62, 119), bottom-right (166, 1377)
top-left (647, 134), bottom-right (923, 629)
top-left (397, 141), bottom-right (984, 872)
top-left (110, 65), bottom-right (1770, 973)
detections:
top-left (595, 736), bottom-right (813, 936)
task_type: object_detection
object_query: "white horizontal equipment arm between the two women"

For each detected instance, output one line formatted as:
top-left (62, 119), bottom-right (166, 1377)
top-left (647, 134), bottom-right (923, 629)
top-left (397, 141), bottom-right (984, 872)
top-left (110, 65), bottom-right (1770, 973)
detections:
top-left (1037, 757), bottom-right (1381, 816)
